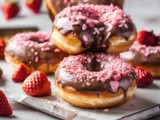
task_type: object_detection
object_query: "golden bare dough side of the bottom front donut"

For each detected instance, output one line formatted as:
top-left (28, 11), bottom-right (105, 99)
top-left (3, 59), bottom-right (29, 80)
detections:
top-left (55, 80), bottom-right (137, 108)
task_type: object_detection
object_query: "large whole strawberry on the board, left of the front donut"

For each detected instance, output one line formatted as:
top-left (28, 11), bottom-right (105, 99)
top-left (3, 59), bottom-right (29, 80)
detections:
top-left (22, 71), bottom-right (51, 96)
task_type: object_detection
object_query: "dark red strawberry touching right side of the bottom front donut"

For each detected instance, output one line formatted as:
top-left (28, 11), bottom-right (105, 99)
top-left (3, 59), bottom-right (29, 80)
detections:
top-left (135, 66), bottom-right (153, 88)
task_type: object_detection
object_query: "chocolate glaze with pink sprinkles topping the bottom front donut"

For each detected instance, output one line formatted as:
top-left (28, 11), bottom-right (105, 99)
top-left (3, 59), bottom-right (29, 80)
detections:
top-left (55, 53), bottom-right (136, 92)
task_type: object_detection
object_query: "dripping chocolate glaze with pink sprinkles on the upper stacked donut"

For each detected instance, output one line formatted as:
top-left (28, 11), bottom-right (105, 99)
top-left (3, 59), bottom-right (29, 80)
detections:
top-left (54, 5), bottom-right (136, 50)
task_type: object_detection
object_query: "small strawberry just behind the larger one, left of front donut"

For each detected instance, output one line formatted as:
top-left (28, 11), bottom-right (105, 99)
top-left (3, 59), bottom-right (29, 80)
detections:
top-left (12, 64), bottom-right (30, 82)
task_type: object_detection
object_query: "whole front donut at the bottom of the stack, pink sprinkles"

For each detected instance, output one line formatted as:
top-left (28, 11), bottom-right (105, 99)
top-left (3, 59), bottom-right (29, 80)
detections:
top-left (55, 53), bottom-right (136, 108)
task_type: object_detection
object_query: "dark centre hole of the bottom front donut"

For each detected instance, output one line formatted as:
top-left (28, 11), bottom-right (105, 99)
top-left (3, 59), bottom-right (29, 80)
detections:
top-left (83, 58), bottom-right (104, 72)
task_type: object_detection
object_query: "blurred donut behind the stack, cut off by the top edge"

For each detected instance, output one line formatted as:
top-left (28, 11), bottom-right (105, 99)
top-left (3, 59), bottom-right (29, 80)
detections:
top-left (45, 0), bottom-right (124, 21)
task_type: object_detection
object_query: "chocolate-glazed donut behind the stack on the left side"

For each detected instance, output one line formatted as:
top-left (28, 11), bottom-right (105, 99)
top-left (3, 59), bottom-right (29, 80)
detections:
top-left (5, 32), bottom-right (68, 74)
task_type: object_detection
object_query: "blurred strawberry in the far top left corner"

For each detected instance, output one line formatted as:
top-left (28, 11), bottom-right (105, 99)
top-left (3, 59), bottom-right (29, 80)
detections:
top-left (2, 0), bottom-right (20, 20)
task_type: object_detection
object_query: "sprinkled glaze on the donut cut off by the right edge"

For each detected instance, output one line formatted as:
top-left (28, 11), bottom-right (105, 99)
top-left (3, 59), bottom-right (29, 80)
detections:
top-left (120, 41), bottom-right (160, 64)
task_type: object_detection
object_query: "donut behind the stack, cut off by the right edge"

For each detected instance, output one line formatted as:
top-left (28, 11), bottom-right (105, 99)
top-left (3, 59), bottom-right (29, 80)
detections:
top-left (120, 41), bottom-right (160, 77)
